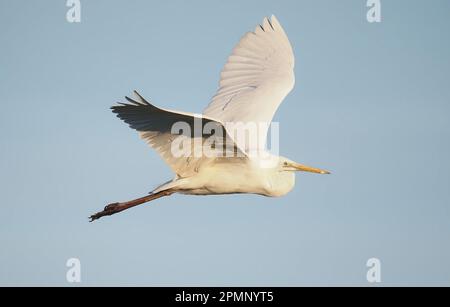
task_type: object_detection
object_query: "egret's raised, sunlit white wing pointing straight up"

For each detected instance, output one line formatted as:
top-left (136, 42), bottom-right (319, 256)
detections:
top-left (203, 16), bottom-right (295, 151)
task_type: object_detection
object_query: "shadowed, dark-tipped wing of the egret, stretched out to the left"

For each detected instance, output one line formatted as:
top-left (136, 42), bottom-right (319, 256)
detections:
top-left (111, 91), bottom-right (246, 177)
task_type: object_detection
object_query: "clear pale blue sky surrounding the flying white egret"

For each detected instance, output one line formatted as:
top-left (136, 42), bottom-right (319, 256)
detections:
top-left (0, 0), bottom-right (450, 286)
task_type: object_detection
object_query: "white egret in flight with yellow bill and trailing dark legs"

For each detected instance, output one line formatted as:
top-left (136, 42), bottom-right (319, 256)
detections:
top-left (90, 15), bottom-right (329, 221)
